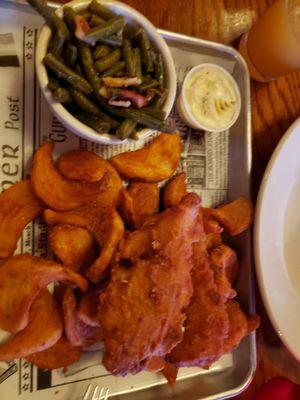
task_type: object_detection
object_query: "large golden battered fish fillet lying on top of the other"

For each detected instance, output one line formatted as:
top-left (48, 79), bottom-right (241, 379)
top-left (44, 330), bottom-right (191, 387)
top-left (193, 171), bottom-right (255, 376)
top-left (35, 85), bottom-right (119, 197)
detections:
top-left (99, 193), bottom-right (204, 375)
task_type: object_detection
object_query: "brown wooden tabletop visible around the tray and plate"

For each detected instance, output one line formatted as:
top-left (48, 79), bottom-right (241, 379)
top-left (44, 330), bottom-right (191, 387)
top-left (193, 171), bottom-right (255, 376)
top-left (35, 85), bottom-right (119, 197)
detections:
top-left (119, 0), bottom-right (300, 400)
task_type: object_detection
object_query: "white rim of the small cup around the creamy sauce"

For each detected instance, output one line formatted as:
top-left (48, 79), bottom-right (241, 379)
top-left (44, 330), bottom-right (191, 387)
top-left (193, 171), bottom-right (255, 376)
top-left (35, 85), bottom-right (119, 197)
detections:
top-left (176, 63), bottom-right (241, 132)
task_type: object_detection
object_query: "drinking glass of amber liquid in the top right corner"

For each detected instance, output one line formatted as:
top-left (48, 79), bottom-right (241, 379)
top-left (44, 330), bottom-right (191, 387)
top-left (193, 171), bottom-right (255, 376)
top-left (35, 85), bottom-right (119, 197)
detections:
top-left (239, 0), bottom-right (300, 82)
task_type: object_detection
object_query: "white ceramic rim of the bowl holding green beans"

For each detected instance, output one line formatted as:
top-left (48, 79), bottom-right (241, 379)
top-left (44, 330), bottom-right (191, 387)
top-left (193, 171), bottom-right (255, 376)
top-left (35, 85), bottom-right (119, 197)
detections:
top-left (36, 0), bottom-right (176, 144)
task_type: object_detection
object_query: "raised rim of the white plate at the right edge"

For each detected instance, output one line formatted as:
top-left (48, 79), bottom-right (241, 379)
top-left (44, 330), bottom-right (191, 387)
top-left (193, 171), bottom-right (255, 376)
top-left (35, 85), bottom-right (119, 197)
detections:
top-left (254, 117), bottom-right (300, 361)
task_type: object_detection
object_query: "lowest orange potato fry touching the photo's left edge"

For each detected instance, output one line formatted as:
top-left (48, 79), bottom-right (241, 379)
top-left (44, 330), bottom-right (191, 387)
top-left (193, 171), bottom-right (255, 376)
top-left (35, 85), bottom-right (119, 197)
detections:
top-left (0, 289), bottom-right (63, 361)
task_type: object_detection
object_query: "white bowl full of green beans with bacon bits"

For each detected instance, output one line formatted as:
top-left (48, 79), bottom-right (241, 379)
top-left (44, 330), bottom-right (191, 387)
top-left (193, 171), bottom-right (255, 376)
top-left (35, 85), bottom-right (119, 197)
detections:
top-left (34, 0), bottom-right (176, 144)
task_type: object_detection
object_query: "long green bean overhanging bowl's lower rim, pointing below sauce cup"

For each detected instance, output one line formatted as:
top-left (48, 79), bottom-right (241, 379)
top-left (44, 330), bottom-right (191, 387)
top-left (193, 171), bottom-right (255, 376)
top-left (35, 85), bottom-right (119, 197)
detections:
top-left (97, 96), bottom-right (175, 133)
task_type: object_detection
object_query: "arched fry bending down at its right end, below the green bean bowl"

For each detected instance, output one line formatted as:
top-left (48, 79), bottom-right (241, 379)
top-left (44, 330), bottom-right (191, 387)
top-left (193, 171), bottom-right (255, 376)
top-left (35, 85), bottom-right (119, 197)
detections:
top-left (57, 150), bottom-right (122, 207)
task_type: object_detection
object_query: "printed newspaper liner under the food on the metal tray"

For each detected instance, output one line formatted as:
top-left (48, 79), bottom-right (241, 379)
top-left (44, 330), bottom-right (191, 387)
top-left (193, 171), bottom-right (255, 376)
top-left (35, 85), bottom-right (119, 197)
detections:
top-left (0, 3), bottom-right (234, 400)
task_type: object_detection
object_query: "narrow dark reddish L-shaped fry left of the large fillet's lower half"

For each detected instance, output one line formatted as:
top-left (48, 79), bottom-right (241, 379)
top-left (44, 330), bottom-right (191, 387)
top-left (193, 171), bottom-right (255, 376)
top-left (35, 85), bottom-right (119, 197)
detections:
top-left (63, 286), bottom-right (103, 347)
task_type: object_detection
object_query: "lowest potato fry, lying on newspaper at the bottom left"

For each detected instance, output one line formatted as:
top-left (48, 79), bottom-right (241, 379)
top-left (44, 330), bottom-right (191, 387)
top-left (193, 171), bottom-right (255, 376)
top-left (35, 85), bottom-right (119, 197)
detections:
top-left (26, 336), bottom-right (82, 369)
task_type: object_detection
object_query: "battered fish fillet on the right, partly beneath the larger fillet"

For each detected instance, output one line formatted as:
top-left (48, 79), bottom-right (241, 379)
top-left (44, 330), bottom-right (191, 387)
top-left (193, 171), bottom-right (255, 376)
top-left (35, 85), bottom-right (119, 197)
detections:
top-left (168, 243), bottom-right (259, 368)
